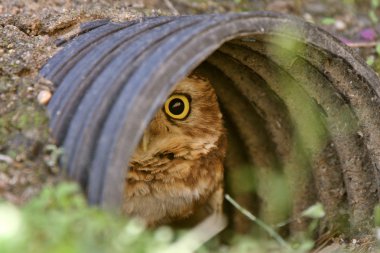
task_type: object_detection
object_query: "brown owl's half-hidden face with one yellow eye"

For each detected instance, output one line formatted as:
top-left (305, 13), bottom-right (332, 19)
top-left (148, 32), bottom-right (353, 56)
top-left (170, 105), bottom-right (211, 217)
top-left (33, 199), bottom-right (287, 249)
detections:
top-left (131, 76), bottom-right (224, 170)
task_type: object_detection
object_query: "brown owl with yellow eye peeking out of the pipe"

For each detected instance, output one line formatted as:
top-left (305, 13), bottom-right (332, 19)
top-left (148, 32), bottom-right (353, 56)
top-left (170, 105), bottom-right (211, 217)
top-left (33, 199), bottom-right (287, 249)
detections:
top-left (123, 75), bottom-right (226, 226)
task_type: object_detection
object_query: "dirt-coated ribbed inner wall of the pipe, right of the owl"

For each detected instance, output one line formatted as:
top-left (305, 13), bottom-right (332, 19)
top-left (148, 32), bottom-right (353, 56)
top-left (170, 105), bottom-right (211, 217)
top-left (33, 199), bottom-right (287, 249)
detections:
top-left (198, 36), bottom-right (378, 235)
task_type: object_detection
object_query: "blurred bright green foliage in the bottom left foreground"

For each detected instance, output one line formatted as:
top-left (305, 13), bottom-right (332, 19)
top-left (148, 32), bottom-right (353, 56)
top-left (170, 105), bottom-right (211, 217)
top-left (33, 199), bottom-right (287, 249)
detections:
top-left (0, 183), bottom-right (163, 253)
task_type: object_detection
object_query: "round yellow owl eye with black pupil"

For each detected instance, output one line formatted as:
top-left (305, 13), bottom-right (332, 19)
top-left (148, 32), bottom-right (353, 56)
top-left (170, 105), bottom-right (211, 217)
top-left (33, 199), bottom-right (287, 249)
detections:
top-left (164, 94), bottom-right (190, 119)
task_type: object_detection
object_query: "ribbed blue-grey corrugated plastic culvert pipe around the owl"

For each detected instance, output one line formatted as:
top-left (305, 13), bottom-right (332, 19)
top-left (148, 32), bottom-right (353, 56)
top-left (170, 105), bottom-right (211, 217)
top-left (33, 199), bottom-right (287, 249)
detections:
top-left (40, 12), bottom-right (380, 237)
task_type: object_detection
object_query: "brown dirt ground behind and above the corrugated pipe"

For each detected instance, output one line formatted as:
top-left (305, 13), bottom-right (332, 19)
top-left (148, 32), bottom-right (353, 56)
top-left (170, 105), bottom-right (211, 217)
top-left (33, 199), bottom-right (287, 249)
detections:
top-left (0, 0), bottom-right (380, 219)
